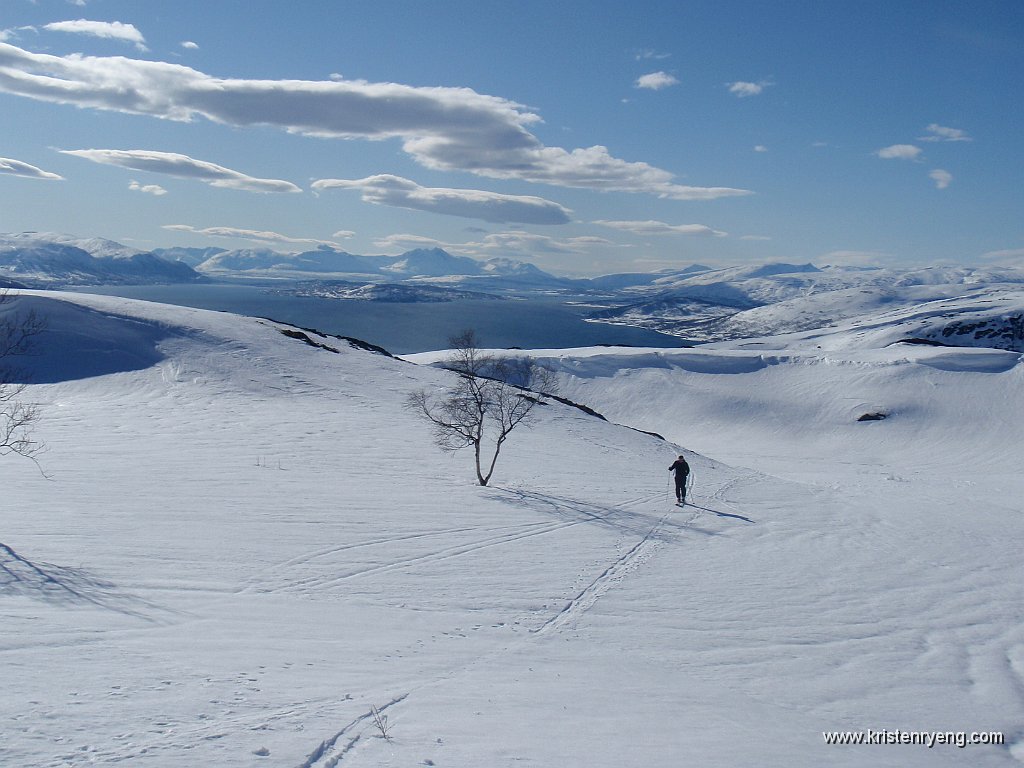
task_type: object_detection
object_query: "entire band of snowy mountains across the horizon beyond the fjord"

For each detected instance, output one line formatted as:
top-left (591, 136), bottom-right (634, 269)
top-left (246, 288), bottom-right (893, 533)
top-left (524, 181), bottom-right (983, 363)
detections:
top-left (0, 232), bottom-right (1024, 348)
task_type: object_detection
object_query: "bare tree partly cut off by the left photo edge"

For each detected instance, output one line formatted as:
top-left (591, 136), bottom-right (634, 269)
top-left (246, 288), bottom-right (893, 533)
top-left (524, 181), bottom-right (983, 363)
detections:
top-left (0, 289), bottom-right (44, 461)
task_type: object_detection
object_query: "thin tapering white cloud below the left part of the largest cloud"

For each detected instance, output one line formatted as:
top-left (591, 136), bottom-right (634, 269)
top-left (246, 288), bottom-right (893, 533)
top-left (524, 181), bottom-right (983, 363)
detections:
top-left (60, 150), bottom-right (302, 193)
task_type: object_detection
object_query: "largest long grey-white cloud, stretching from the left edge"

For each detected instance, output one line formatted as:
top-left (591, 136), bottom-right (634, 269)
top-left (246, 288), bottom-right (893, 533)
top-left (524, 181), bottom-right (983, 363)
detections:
top-left (0, 43), bottom-right (752, 200)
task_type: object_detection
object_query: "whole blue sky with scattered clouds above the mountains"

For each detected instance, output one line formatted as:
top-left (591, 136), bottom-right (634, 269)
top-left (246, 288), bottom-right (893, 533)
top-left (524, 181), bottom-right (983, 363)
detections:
top-left (0, 0), bottom-right (1024, 274)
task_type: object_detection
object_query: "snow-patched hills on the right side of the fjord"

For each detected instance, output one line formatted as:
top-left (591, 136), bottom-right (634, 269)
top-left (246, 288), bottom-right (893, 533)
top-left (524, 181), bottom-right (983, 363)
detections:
top-left (590, 264), bottom-right (1024, 348)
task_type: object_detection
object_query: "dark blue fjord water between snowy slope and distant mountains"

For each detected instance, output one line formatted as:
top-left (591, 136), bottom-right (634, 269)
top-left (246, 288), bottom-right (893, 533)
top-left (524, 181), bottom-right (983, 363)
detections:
top-left (68, 284), bottom-right (687, 354)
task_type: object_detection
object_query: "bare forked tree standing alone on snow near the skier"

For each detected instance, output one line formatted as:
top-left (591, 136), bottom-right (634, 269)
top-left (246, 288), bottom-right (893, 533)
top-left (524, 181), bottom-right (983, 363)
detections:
top-left (408, 331), bottom-right (555, 485)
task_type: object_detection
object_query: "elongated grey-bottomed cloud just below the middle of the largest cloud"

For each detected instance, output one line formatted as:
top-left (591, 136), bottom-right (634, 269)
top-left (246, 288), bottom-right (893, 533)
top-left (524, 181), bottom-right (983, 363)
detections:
top-left (312, 174), bottom-right (570, 224)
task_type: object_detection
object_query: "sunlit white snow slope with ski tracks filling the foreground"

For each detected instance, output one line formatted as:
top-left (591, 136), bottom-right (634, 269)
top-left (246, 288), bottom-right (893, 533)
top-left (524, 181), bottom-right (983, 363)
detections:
top-left (0, 294), bottom-right (1024, 768)
